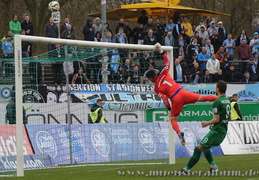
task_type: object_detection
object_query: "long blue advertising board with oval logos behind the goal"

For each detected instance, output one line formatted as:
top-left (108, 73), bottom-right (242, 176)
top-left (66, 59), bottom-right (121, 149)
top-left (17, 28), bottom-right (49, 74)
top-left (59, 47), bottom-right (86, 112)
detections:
top-left (26, 122), bottom-right (223, 164)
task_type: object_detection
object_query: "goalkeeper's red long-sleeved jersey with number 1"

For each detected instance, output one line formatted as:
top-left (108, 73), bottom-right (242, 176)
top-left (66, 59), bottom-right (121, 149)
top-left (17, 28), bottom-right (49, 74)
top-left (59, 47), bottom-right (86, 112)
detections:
top-left (155, 54), bottom-right (182, 108)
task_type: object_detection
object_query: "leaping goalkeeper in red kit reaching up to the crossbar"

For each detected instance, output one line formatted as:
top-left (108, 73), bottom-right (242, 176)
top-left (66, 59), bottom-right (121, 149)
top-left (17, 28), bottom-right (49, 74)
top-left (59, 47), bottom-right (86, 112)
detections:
top-left (146, 43), bottom-right (218, 146)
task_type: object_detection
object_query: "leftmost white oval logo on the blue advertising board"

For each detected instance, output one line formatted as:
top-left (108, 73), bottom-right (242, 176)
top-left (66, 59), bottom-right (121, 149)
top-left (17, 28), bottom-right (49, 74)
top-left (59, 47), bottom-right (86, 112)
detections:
top-left (36, 131), bottom-right (58, 158)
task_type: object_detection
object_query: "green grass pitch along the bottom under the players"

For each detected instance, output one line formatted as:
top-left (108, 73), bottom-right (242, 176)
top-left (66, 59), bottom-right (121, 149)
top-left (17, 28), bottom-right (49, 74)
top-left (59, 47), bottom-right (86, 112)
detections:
top-left (0, 154), bottom-right (259, 180)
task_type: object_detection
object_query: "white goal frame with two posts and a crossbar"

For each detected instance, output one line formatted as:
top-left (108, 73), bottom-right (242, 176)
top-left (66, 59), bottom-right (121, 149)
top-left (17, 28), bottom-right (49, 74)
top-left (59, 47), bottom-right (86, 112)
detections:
top-left (14, 35), bottom-right (175, 176)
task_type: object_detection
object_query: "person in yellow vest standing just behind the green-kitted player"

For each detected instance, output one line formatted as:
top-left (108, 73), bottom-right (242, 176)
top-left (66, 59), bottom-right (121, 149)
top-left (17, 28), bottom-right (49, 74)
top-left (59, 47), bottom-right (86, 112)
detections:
top-left (230, 94), bottom-right (243, 121)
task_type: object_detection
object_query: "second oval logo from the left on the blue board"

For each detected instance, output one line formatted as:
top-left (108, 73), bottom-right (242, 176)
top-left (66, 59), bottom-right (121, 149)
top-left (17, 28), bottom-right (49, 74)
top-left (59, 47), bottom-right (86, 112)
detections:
top-left (91, 130), bottom-right (110, 157)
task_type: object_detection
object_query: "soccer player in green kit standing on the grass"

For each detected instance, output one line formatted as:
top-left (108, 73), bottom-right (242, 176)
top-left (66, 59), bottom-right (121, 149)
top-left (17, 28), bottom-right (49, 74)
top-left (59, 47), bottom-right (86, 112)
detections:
top-left (181, 81), bottom-right (230, 175)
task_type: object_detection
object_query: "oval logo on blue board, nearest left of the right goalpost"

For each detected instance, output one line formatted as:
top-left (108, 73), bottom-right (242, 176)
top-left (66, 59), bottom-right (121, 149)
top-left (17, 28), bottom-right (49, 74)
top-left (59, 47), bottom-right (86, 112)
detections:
top-left (138, 128), bottom-right (156, 154)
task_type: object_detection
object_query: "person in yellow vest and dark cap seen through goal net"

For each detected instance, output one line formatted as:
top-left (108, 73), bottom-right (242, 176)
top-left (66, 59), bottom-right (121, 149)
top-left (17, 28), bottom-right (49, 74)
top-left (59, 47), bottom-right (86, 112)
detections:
top-left (90, 99), bottom-right (107, 123)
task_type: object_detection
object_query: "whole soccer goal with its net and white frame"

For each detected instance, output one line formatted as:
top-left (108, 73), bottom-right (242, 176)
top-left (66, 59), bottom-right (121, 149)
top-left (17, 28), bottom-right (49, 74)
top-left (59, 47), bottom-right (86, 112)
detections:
top-left (0, 35), bottom-right (175, 176)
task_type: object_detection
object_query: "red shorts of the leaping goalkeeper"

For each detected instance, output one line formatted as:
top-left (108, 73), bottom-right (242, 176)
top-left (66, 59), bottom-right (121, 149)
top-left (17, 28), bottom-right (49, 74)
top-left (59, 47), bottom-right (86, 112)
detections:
top-left (170, 89), bottom-right (201, 116)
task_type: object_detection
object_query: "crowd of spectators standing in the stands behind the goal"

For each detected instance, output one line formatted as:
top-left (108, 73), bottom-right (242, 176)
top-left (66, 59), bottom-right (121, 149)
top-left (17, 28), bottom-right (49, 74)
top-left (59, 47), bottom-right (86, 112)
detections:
top-left (2, 11), bottom-right (259, 84)
